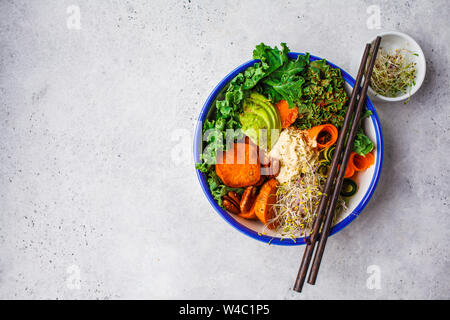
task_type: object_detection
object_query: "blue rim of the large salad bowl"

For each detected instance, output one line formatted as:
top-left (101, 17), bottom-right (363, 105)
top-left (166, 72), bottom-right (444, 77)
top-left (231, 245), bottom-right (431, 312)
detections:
top-left (194, 52), bottom-right (383, 246)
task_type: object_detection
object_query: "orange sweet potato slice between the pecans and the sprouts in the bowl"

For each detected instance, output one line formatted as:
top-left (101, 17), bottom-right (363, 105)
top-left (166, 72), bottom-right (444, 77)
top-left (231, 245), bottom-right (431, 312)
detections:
top-left (255, 179), bottom-right (278, 229)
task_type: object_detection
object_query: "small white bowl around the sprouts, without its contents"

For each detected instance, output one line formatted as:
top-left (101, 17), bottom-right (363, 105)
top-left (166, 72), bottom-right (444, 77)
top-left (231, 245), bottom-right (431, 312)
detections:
top-left (369, 31), bottom-right (427, 102)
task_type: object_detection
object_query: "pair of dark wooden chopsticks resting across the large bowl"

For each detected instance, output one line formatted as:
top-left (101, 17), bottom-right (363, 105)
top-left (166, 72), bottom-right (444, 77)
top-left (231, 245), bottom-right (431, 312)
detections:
top-left (293, 37), bottom-right (381, 292)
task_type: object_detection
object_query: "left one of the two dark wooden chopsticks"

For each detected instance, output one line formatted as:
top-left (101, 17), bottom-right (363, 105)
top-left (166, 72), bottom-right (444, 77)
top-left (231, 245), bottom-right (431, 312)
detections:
top-left (293, 40), bottom-right (371, 292)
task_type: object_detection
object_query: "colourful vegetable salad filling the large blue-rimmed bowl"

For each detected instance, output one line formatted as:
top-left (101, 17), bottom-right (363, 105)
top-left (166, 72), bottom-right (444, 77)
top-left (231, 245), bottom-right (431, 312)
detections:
top-left (196, 43), bottom-right (375, 241)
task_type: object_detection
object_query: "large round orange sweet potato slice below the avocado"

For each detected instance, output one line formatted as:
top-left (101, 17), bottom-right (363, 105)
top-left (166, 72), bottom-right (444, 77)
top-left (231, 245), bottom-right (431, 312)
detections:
top-left (216, 143), bottom-right (261, 188)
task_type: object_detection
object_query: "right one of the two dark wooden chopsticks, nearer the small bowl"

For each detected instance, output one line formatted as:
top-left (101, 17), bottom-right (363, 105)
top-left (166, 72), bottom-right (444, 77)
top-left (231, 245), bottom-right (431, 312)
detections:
top-left (308, 37), bottom-right (381, 284)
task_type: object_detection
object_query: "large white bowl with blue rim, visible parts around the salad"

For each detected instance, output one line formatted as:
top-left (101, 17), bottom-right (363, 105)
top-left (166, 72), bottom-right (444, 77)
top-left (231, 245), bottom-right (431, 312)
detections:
top-left (194, 52), bottom-right (383, 246)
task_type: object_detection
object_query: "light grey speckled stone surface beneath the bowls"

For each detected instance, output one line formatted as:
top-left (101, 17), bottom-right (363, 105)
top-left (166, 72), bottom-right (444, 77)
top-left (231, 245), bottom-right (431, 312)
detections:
top-left (0, 0), bottom-right (450, 299)
